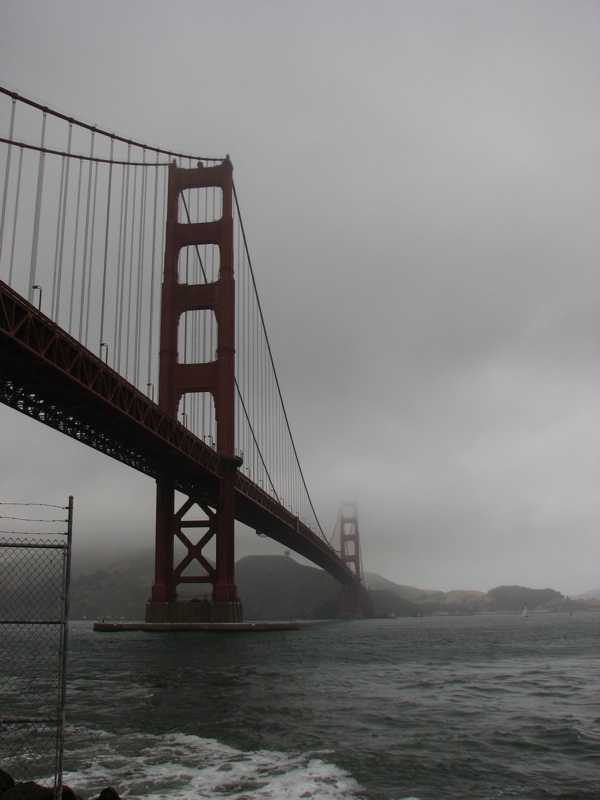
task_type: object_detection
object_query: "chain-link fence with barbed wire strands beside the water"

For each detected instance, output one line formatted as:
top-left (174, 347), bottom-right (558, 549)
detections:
top-left (0, 497), bottom-right (73, 798)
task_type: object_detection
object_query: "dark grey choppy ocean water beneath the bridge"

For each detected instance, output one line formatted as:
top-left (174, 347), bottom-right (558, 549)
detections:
top-left (35, 613), bottom-right (600, 800)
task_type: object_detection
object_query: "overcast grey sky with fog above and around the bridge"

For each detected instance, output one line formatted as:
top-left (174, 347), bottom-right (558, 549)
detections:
top-left (0, 0), bottom-right (600, 594)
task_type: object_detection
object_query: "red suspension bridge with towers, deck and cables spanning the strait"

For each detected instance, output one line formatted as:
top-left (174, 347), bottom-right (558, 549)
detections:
top-left (0, 88), bottom-right (368, 623)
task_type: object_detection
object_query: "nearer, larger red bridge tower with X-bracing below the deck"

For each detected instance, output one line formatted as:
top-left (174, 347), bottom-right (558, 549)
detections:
top-left (146, 159), bottom-right (242, 622)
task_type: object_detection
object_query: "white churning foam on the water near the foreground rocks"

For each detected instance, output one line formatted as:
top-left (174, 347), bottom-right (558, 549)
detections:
top-left (64, 729), bottom-right (364, 800)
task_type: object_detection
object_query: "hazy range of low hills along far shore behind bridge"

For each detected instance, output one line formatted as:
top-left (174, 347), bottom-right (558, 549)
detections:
top-left (70, 550), bottom-right (600, 620)
